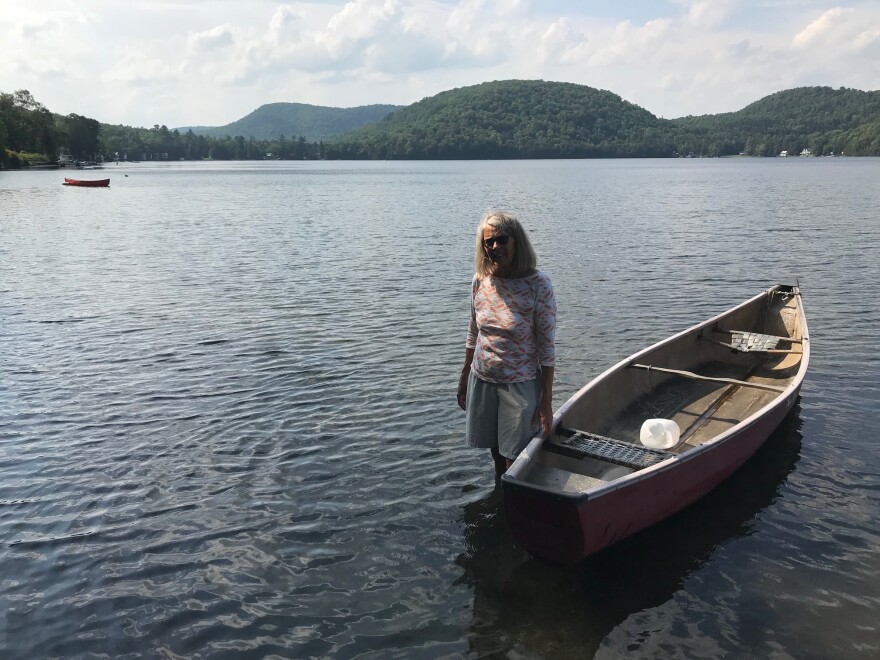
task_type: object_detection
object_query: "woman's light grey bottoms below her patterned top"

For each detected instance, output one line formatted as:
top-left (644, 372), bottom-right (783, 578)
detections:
top-left (465, 371), bottom-right (541, 460)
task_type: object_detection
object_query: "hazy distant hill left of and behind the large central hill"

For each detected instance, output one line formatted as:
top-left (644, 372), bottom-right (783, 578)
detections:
top-left (178, 103), bottom-right (400, 142)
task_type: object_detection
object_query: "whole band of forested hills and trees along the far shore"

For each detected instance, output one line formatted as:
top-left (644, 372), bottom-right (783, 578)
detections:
top-left (0, 80), bottom-right (880, 167)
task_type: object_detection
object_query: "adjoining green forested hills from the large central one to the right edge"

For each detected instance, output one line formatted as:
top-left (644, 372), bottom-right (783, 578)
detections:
top-left (328, 80), bottom-right (880, 158)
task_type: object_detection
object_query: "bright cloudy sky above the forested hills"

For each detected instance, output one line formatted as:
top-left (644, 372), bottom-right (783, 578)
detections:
top-left (0, 0), bottom-right (880, 128)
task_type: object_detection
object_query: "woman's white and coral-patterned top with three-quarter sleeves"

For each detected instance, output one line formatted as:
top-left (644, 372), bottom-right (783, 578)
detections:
top-left (465, 271), bottom-right (556, 383)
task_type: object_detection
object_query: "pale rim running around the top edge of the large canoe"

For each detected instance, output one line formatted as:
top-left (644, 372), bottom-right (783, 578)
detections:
top-left (501, 285), bottom-right (810, 505)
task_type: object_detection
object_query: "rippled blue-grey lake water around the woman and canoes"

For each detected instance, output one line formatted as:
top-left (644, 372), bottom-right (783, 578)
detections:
top-left (0, 158), bottom-right (880, 658)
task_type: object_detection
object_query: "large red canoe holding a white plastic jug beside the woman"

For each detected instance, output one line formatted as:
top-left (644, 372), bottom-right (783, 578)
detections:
top-left (501, 285), bottom-right (810, 564)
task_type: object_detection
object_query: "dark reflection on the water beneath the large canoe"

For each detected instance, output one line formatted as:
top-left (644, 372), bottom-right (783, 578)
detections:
top-left (456, 403), bottom-right (802, 658)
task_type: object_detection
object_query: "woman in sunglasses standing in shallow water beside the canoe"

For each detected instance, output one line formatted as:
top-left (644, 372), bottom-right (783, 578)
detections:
top-left (458, 211), bottom-right (556, 476)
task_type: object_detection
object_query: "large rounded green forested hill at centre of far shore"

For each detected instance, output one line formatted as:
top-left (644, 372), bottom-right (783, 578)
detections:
top-left (328, 80), bottom-right (673, 159)
